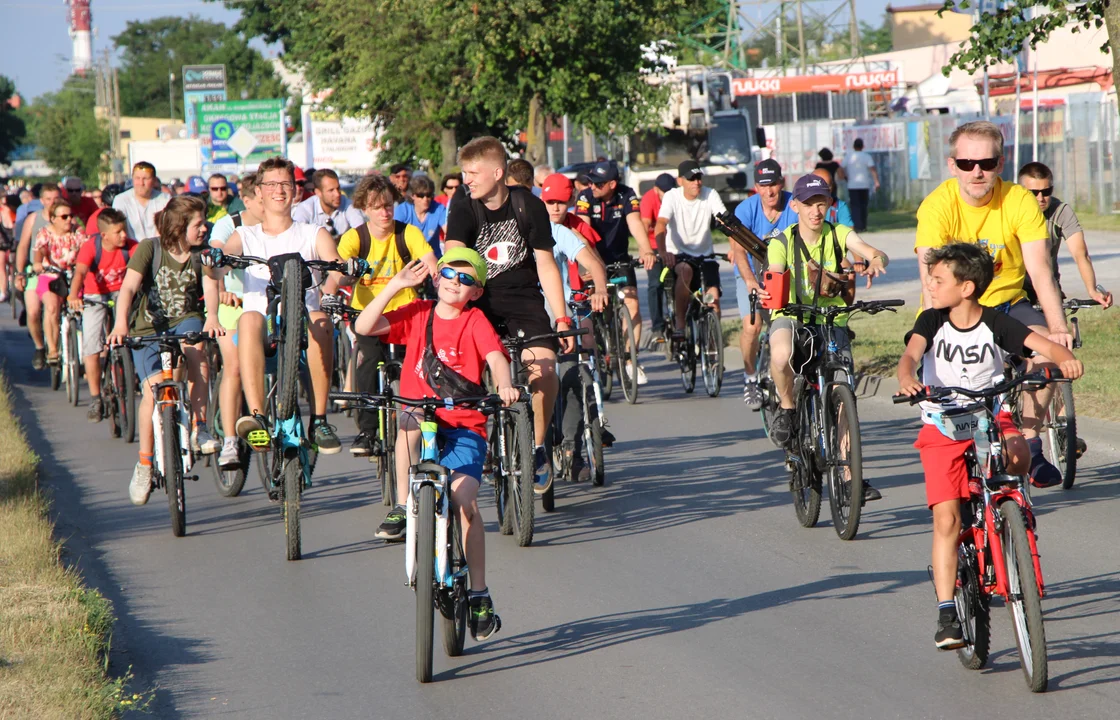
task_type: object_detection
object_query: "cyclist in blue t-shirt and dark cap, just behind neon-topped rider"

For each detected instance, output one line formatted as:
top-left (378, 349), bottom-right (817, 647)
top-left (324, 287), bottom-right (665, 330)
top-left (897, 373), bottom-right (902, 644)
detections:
top-left (731, 159), bottom-right (797, 410)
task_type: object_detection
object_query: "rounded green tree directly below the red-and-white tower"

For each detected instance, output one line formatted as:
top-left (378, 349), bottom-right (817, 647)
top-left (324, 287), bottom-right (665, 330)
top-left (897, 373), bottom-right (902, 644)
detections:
top-left (29, 75), bottom-right (109, 185)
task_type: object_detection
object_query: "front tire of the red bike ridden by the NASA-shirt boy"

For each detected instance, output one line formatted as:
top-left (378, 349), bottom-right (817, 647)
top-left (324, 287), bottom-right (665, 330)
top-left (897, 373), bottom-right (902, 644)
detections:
top-left (999, 498), bottom-right (1049, 692)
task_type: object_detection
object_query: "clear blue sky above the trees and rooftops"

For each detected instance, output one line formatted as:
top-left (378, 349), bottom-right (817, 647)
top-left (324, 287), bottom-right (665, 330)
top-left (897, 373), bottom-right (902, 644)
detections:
top-left (0, 0), bottom-right (891, 99)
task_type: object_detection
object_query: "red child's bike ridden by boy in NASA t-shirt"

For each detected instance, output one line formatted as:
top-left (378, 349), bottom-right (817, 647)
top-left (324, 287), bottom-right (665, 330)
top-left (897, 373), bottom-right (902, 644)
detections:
top-left (894, 371), bottom-right (1062, 692)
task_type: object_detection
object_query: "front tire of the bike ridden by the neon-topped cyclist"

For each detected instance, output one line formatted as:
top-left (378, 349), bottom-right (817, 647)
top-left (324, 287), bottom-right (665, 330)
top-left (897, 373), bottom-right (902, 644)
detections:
top-left (828, 385), bottom-right (864, 540)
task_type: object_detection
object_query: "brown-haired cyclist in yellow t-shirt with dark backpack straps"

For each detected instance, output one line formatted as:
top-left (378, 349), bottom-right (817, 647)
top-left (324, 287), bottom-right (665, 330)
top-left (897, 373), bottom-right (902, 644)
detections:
top-left (338, 175), bottom-right (437, 457)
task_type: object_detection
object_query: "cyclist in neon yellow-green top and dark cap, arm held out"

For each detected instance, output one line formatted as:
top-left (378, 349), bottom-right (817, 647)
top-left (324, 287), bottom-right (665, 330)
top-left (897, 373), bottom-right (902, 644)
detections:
top-left (767, 175), bottom-right (888, 502)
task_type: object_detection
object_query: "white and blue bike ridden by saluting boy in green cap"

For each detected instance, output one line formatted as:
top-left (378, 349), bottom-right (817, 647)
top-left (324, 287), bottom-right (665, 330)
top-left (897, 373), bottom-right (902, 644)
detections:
top-left (330, 393), bottom-right (512, 683)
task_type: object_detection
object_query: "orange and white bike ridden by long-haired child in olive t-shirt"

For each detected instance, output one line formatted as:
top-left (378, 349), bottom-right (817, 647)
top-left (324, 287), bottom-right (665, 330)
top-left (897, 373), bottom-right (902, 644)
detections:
top-left (124, 333), bottom-right (211, 537)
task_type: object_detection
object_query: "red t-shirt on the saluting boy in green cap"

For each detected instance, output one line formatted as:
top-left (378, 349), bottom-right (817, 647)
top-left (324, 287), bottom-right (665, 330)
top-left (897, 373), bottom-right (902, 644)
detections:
top-left (382, 300), bottom-right (510, 438)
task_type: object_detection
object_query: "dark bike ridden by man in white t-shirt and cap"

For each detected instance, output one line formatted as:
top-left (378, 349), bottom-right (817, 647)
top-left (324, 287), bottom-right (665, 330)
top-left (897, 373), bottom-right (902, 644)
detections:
top-left (661, 253), bottom-right (726, 398)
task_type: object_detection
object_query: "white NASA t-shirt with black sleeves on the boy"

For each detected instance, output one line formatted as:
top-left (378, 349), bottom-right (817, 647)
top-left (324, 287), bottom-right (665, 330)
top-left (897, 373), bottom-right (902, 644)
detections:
top-left (905, 308), bottom-right (1030, 424)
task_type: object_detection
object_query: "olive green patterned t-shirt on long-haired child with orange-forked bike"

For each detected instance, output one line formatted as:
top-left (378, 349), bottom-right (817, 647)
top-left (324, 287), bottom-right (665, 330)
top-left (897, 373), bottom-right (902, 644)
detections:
top-left (129, 237), bottom-right (203, 336)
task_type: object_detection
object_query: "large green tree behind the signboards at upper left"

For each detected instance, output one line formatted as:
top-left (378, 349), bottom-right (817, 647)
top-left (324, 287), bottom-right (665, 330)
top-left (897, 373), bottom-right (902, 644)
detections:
top-left (113, 16), bottom-right (286, 118)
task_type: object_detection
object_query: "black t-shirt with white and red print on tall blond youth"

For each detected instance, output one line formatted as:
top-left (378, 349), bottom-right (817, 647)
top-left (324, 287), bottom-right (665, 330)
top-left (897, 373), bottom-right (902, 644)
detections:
top-left (447, 188), bottom-right (552, 292)
